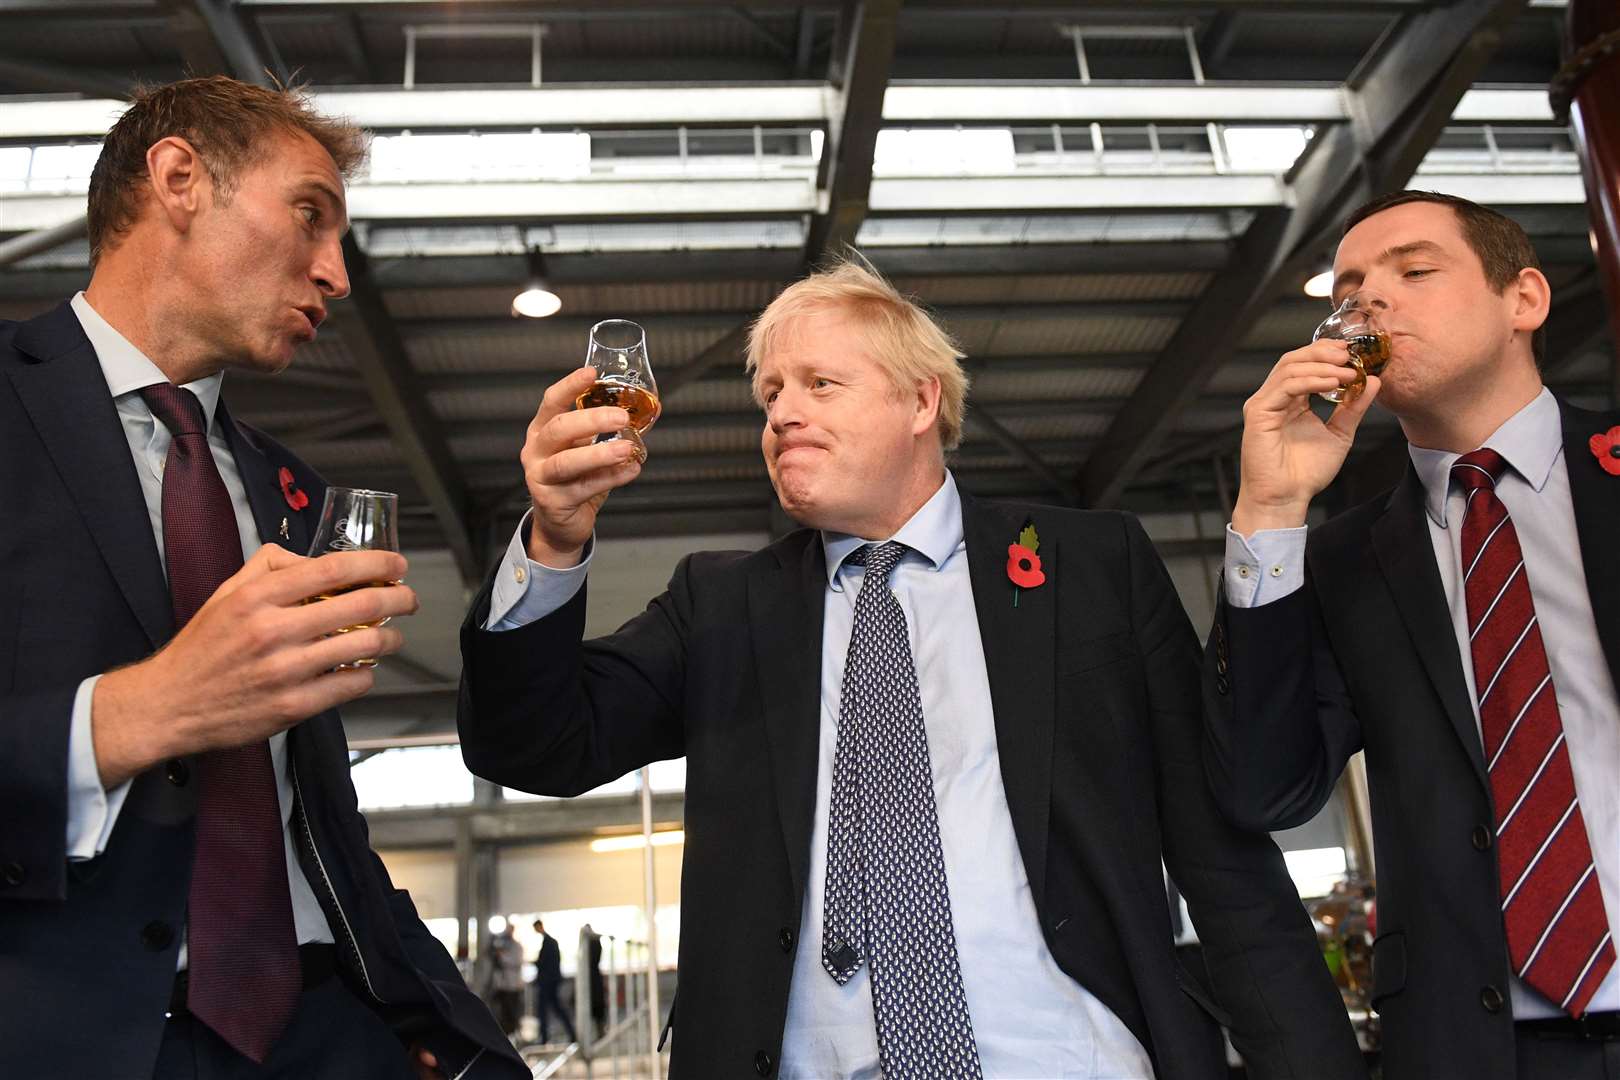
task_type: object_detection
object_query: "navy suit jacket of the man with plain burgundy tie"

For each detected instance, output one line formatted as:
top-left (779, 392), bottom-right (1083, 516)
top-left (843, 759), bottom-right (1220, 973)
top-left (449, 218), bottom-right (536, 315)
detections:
top-left (0, 304), bottom-right (528, 1080)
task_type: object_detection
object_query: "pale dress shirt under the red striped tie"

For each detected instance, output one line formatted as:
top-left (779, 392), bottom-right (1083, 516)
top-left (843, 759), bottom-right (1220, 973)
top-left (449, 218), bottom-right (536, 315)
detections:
top-left (1225, 389), bottom-right (1620, 1020)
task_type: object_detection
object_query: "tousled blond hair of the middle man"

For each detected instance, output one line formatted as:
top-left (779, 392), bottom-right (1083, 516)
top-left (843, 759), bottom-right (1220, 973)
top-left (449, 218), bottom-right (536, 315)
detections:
top-left (748, 248), bottom-right (967, 450)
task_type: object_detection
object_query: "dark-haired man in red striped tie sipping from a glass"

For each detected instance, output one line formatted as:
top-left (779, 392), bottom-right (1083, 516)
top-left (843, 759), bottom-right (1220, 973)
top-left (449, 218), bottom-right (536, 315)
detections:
top-left (1205, 193), bottom-right (1620, 1080)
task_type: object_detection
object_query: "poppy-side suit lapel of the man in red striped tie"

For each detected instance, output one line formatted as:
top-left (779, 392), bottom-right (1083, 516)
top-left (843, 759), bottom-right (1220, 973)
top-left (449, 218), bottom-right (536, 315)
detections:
top-left (1558, 402), bottom-right (1620, 685)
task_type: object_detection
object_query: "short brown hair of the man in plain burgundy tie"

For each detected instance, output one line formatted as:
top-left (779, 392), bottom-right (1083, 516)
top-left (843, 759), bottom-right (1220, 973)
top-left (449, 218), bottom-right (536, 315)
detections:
top-left (89, 74), bottom-right (366, 266)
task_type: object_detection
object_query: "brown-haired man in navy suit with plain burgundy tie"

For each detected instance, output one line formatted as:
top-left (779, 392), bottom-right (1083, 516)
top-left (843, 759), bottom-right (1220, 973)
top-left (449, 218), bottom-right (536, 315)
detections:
top-left (0, 79), bottom-right (528, 1080)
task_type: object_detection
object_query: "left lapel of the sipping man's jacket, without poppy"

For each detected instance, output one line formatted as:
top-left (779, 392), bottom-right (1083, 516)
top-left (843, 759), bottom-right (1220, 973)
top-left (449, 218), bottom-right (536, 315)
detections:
top-left (1372, 466), bottom-right (1490, 790)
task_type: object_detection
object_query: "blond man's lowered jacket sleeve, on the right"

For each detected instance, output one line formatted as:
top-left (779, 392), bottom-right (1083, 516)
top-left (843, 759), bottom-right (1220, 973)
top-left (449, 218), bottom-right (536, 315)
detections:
top-left (1128, 518), bottom-right (1367, 1080)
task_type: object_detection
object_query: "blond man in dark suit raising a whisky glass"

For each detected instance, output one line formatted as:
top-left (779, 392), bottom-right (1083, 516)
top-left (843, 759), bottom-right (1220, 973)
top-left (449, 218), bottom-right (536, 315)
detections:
top-left (460, 264), bottom-right (1364, 1080)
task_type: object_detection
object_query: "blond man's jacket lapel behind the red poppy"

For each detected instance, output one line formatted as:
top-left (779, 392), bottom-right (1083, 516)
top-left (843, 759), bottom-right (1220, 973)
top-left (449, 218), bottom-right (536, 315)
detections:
top-left (962, 494), bottom-right (1063, 905)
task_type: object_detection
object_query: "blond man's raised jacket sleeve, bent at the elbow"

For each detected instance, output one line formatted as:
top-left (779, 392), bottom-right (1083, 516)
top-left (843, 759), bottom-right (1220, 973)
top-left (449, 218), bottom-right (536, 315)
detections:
top-left (457, 555), bottom-right (693, 797)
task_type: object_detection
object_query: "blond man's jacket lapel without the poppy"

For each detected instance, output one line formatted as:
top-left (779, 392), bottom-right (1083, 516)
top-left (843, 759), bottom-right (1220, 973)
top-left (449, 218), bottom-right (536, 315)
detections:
top-left (748, 531), bottom-right (826, 895)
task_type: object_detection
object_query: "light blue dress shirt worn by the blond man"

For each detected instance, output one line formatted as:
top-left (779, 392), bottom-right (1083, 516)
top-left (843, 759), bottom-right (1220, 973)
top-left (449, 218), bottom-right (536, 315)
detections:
top-left (486, 473), bottom-right (1153, 1080)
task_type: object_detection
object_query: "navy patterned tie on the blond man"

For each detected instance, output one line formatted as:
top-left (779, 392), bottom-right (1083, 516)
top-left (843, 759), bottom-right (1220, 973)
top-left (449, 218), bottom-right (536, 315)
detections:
top-left (821, 541), bottom-right (983, 1080)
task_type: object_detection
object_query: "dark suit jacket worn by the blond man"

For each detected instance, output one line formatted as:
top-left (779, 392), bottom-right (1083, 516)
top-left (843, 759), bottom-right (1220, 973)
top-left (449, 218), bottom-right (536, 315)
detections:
top-left (458, 495), bottom-right (1366, 1080)
